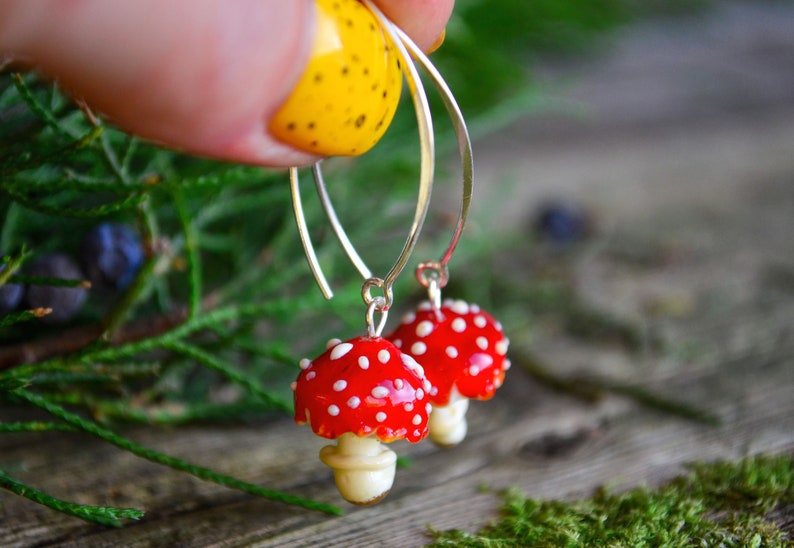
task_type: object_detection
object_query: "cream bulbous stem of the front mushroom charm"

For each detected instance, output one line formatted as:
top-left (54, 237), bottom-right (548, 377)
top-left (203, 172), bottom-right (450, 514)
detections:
top-left (320, 433), bottom-right (397, 505)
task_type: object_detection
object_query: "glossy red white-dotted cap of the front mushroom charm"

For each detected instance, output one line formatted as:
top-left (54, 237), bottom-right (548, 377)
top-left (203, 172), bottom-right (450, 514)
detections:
top-left (294, 337), bottom-right (432, 442)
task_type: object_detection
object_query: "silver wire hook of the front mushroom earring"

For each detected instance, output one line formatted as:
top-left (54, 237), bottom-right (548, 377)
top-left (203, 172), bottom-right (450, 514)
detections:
top-left (290, 0), bottom-right (435, 312)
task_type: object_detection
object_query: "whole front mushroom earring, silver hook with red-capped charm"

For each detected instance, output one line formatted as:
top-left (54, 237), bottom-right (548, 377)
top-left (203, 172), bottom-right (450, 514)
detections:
top-left (290, 1), bottom-right (435, 505)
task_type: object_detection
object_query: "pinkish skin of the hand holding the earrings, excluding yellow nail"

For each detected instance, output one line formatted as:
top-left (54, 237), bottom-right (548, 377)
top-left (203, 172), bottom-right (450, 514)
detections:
top-left (0, 0), bottom-right (454, 167)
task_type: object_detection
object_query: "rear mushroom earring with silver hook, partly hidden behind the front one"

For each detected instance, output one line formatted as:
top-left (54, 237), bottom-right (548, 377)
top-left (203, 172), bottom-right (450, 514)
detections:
top-left (380, 51), bottom-right (510, 447)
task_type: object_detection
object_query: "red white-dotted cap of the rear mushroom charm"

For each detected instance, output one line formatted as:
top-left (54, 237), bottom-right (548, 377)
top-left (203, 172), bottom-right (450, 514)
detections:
top-left (387, 300), bottom-right (510, 406)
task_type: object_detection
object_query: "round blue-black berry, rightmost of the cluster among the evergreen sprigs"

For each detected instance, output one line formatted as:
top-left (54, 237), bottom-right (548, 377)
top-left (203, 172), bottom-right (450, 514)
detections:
top-left (80, 223), bottom-right (143, 289)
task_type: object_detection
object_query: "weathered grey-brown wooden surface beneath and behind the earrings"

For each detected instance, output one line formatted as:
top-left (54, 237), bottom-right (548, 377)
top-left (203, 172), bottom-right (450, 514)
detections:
top-left (0, 4), bottom-right (794, 547)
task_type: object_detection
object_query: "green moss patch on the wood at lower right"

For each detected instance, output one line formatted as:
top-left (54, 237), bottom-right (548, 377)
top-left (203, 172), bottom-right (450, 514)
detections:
top-left (431, 456), bottom-right (794, 547)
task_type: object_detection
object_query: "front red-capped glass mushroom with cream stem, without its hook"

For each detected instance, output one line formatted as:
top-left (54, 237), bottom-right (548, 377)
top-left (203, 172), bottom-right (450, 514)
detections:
top-left (293, 337), bottom-right (432, 505)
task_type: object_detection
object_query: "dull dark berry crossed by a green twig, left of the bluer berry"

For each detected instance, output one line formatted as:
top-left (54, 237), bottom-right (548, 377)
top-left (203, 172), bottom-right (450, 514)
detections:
top-left (26, 253), bottom-right (88, 323)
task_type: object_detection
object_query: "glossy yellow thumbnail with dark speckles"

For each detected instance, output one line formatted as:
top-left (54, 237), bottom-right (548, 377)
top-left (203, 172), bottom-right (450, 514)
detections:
top-left (269, 0), bottom-right (402, 156)
